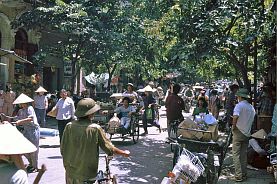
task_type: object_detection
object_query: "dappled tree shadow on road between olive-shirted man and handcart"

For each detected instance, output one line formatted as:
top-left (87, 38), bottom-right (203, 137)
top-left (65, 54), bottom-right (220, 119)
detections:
top-left (111, 134), bottom-right (172, 184)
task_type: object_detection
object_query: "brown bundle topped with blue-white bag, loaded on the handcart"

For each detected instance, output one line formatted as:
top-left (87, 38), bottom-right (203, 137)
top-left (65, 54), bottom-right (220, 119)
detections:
top-left (177, 114), bottom-right (218, 141)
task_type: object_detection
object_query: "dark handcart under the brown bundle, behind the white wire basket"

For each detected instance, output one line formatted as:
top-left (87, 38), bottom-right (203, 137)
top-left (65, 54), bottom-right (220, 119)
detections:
top-left (168, 128), bottom-right (231, 184)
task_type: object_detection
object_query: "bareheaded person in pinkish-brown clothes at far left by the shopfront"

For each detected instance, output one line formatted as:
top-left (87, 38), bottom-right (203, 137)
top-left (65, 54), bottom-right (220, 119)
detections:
top-left (3, 84), bottom-right (16, 116)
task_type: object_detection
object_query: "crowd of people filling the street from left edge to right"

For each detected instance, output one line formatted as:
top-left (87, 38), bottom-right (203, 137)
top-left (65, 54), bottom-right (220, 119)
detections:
top-left (0, 82), bottom-right (276, 184)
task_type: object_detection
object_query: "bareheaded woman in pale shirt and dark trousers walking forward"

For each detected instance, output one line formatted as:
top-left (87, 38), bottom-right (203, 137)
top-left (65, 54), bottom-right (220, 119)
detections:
top-left (54, 89), bottom-right (75, 142)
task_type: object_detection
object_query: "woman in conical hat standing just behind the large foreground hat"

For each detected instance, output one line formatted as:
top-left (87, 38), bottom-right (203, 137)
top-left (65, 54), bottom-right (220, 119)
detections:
top-left (13, 93), bottom-right (40, 172)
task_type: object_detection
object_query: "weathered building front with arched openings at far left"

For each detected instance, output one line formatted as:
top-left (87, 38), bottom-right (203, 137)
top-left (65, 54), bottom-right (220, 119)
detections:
top-left (0, 0), bottom-right (64, 93)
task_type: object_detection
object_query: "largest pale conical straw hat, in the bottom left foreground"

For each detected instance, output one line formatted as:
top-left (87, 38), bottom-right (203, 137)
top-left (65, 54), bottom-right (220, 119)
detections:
top-left (0, 123), bottom-right (37, 155)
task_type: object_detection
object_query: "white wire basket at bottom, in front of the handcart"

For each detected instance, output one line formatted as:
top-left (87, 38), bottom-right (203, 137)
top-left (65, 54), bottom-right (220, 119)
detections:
top-left (172, 148), bottom-right (205, 182)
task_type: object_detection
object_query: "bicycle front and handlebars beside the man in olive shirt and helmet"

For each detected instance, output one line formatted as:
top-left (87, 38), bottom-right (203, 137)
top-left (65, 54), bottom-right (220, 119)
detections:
top-left (84, 154), bottom-right (117, 184)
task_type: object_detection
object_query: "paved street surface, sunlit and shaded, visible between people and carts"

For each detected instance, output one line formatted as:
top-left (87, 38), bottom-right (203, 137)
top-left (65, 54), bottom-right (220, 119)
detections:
top-left (26, 108), bottom-right (273, 184)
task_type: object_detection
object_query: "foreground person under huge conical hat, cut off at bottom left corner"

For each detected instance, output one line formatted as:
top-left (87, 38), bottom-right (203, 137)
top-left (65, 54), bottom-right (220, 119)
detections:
top-left (0, 122), bottom-right (37, 184)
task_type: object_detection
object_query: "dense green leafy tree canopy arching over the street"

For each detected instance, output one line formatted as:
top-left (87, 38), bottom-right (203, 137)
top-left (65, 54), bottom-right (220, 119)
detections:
top-left (14, 0), bottom-right (276, 91)
